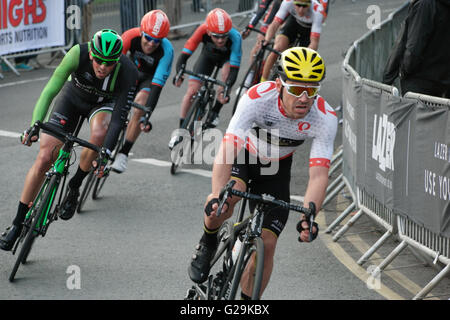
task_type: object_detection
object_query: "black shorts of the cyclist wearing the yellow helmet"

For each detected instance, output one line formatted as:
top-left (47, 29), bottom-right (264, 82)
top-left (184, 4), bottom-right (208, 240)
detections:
top-left (231, 149), bottom-right (292, 238)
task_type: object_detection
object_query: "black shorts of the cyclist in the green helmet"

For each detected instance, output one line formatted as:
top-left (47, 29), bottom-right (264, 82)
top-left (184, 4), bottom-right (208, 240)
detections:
top-left (43, 82), bottom-right (113, 140)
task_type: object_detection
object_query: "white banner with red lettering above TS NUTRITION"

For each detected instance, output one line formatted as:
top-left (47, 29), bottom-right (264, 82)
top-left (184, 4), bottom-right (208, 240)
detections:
top-left (0, 0), bottom-right (65, 56)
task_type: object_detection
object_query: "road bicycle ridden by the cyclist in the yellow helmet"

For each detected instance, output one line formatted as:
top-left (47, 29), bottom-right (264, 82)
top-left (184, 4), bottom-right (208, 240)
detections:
top-left (185, 180), bottom-right (315, 300)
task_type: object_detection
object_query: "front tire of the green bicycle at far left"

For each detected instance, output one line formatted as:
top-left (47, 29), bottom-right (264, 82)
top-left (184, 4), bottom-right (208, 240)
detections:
top-left (9, 175), bottom-right (58, 282)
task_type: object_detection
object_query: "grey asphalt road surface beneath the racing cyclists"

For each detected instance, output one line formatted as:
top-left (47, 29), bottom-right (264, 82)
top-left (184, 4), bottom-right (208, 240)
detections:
top-left (0, 0), bottom-right (448, 300)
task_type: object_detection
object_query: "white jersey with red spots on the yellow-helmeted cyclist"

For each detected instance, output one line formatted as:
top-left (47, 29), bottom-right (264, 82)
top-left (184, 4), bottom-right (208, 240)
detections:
top-left (224, 81), bottom-right (338, 167)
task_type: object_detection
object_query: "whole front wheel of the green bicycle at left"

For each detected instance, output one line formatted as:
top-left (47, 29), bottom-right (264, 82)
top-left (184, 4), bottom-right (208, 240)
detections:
top-left (9, 175), bottom-right (59, 282)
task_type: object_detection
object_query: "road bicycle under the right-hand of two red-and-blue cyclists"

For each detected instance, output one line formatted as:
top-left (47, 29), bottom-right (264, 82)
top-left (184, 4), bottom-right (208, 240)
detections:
top-left (170, 65), bottom-right (229, 174)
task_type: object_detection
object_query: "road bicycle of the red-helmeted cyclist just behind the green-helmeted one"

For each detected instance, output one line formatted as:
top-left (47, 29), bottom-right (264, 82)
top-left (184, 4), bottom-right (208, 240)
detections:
top-left (77, 102), bottom-right (149, 213)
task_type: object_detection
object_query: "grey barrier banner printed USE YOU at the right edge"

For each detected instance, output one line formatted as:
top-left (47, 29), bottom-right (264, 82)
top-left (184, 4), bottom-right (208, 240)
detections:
top-left (395, 99), bottom-right (450, 237)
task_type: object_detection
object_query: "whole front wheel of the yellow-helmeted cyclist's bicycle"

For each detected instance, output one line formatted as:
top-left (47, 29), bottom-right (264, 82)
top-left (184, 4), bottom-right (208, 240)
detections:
top-left (229, 237), bottom-right (264, 300)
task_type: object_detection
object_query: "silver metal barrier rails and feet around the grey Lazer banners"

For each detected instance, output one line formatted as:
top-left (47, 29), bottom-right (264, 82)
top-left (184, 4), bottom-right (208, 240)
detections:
top-left (338, 3), bottom-right (450, 299)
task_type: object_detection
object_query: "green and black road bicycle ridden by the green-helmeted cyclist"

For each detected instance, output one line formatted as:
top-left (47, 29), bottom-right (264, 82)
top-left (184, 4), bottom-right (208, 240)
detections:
top-left (9, 121), bottom-right (107, 282)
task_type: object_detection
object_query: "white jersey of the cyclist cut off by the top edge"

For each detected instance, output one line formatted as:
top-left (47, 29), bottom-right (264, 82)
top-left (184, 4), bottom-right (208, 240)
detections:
top-left (274, 0), bottom-right (326, 38)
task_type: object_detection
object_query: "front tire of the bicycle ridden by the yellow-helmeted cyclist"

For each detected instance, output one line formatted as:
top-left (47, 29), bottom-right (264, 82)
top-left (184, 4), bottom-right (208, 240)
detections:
top-left (228, 237), bottom-right (264, 300)
